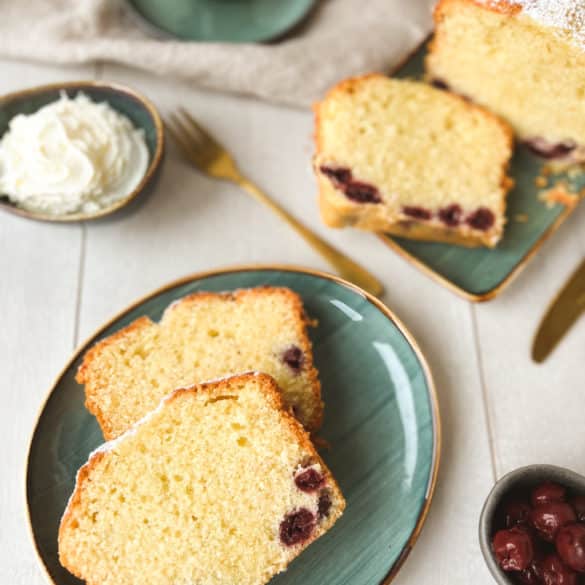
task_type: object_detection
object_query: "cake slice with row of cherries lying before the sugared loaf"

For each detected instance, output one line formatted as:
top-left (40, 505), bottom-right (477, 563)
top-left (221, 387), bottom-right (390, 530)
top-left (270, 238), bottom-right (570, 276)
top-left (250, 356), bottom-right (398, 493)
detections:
top-left (314, 74), bottom-right (513, 247)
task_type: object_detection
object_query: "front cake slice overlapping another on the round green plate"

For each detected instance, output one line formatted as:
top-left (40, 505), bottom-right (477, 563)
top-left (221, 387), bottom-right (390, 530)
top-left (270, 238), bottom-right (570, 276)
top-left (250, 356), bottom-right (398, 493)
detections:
top-left (59, 373), bottom-right (345, 585)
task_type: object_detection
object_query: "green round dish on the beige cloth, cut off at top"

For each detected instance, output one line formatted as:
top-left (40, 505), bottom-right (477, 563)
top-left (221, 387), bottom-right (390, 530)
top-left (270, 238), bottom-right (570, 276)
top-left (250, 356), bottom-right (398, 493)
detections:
top-left (129, 0), bottom-right (315, 43)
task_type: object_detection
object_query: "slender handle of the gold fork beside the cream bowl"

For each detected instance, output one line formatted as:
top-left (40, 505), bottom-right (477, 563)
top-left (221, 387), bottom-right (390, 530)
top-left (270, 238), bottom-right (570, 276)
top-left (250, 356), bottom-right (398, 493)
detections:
top-left (237, 177), bottom-right (384, 296)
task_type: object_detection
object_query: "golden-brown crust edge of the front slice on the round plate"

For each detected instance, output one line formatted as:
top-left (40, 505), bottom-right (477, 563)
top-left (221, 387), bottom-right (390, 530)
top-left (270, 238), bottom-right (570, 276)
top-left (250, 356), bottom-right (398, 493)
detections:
top-left (58, 372), bottom-right (346, 585)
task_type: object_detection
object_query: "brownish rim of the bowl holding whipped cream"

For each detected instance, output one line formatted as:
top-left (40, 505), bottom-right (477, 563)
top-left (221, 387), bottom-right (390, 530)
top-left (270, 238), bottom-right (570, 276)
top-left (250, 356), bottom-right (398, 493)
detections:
top-left (0, 80), bottom-right (165, 223)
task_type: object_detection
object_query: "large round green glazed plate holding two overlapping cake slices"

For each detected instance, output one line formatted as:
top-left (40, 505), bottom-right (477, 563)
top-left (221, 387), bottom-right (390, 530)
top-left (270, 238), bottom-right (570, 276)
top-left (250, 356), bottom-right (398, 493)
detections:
top-left (26, 267), bottom-right (440, 585)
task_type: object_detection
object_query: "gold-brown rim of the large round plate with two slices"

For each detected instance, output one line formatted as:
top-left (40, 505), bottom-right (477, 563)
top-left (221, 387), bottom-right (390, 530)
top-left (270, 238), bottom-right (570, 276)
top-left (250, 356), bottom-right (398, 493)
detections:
top-left (24, 264), bottom-right (442, 585)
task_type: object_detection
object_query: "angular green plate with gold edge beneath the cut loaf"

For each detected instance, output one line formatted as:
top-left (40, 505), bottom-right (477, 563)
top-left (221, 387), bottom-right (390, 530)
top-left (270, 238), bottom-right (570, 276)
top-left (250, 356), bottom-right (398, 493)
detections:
top-left (382, 46), bottom-right (585, 301)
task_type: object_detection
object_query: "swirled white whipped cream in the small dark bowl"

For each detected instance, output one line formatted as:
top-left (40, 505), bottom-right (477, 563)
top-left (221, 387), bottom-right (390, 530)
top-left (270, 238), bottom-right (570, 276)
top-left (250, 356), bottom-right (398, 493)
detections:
top-left (0, 92), bottom-right (149, 215)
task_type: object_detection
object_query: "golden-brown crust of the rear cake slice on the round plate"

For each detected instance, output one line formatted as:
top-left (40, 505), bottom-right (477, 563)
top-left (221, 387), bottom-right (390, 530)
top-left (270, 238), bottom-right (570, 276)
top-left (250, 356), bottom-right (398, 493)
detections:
top-left (75, 286), bottom-right (323, 440)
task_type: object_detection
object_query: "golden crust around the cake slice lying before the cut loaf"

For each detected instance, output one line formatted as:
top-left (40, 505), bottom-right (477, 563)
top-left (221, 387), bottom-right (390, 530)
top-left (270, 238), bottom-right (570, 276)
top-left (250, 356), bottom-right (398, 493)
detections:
top-left (313, 74), bottom-right (514, 248)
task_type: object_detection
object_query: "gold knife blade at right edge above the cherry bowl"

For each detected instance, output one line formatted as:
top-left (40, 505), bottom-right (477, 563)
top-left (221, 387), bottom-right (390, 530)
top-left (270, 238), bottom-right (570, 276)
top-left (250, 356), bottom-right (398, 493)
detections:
top-left (532, 260), bottom-right (585, 363)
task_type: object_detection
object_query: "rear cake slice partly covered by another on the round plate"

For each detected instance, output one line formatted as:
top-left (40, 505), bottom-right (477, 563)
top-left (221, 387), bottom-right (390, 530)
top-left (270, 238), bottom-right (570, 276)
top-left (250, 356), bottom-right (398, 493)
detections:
top-left (77, 287), bottom-right (323, 439)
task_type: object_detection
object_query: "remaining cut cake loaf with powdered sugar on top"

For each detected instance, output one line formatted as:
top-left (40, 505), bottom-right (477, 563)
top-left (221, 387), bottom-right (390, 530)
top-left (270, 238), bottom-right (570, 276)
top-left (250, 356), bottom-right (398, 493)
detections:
top-left (426, 0), bottom-right (585, 162)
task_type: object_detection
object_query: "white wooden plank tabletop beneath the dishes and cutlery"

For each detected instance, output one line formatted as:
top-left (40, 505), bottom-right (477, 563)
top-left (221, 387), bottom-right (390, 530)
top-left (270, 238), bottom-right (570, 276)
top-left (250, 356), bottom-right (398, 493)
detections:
top-left (0, 56), bottom-right (585, 585)
